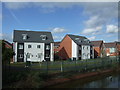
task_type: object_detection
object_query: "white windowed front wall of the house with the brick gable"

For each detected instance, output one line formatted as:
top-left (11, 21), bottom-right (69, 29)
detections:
top-left (82, 45), bottom-right (90, 59)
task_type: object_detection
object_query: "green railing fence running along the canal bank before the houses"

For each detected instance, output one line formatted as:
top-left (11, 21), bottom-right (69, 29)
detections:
top-left (31, 57), bottom-right (119, 74)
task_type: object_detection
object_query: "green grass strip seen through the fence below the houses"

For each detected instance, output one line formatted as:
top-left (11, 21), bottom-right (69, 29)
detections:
top-left (11, 58), bottom-right (117, 73)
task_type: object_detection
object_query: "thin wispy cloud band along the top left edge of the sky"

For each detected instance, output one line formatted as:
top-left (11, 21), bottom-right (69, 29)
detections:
top-left (4, 2), bottom-right (78, 10)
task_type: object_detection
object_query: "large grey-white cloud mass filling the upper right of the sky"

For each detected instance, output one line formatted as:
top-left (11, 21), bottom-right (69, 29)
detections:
top-left (82, 2), bottom-right (118, 35)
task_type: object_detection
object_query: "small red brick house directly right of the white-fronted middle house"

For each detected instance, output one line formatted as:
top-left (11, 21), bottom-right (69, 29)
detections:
top-left (91, 40), bottom-right (104, 58)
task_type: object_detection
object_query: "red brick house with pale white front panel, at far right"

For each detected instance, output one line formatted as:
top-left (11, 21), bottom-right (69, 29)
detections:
top-left (105, 42), bottom-right (120, 56)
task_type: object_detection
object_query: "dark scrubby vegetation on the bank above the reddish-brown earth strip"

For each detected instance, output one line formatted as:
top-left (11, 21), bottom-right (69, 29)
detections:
top-left (3, 64), bottom-right (118, 88)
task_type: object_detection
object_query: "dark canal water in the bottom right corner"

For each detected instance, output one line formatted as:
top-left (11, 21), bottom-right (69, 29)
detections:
top-left (50, 72), bottom-right (120, 88)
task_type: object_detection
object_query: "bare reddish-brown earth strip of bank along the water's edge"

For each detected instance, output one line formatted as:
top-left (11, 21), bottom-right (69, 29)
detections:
top-left (44, 66), bottom-right (120, 88)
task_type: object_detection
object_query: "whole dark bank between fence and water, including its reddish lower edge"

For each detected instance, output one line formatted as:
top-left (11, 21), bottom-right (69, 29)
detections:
top-left (3, 66), bottom-right (120, 88)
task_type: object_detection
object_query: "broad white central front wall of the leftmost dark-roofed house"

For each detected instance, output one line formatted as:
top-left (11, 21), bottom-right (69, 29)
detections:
top-left (24, 42), bottom-right (45, 62)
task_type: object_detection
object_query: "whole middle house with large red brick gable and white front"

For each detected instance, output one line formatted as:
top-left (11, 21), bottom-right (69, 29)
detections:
top-left (58, 34), bottom-right (94, 60)
